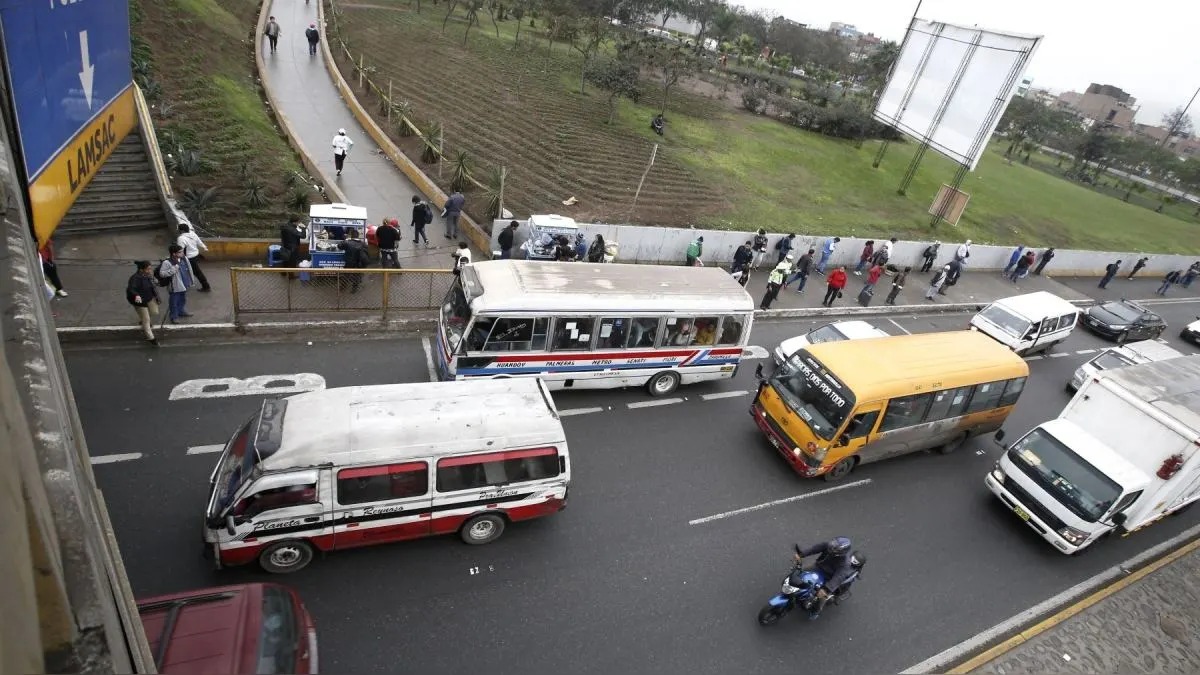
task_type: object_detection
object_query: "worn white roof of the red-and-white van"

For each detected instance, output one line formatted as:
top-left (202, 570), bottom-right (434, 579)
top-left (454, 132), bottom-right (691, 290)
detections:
top-left (262, 377), bottom-right (565, 471)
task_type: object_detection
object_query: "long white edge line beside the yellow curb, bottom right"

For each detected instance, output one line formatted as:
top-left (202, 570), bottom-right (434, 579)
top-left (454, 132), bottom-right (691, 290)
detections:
top-left (901, 516), bottom-right (1200, 674)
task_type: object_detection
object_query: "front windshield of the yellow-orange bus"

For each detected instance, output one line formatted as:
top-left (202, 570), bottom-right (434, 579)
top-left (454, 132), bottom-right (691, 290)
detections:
top-left (770, 350), bottom-right (854, 441)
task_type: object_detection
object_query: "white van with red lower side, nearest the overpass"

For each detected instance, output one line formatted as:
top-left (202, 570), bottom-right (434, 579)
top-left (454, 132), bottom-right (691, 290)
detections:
top-left (204, 377), bottom-right (570, 573)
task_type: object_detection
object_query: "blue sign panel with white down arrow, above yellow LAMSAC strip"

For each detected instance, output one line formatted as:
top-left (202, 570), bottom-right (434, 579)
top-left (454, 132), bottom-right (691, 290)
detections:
top-left (0, 0), bottom-right (133, 183)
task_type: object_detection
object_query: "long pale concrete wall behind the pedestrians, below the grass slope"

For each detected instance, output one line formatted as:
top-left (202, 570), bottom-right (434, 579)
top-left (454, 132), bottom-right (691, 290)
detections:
top-left (491, 220), bottom-right (1200, 276)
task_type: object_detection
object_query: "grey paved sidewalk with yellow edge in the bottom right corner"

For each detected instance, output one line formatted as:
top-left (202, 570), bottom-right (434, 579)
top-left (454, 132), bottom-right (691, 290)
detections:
top-left (949, 533), bottom-right (1200, 675)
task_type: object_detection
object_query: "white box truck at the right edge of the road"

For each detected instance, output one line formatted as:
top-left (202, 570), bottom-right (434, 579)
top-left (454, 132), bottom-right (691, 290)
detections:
top-left (984, 356), bottom-right (1200, 555)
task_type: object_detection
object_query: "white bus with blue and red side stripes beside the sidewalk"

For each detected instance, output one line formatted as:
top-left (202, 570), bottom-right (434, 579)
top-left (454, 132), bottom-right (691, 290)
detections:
top-left (434, 261), bottom-right (755, 396)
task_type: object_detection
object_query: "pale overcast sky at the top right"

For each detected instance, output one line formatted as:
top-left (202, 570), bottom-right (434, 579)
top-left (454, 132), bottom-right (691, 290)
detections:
top-left (744, 0), bottom-right (1200, 124)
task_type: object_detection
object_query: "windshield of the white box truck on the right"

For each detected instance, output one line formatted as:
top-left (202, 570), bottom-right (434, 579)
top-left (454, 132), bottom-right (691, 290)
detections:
top-left (1008, 429), bottom-right (1121, 522)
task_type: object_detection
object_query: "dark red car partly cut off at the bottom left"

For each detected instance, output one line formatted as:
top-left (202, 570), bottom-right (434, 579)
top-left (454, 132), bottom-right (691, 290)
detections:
top-left (138, 584), bottom-right (317, 675)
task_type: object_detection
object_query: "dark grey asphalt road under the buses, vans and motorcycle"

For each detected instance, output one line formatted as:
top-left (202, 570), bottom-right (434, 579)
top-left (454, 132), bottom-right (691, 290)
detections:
top-left (67, 301), bottom-right (1200, 674)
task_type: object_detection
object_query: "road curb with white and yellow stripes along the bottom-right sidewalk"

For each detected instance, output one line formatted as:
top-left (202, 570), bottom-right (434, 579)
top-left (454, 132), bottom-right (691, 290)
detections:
top-left (901, 525), bottom-right (1200, 675)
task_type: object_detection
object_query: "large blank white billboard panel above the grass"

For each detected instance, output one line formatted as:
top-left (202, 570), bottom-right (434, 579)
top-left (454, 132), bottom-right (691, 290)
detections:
top-left (875, 18), bottom-right (1042, 169)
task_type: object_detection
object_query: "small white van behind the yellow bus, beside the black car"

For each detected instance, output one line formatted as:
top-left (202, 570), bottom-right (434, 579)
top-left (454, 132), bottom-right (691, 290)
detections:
top-left (971, 291), bottom-right (1079, 356)
